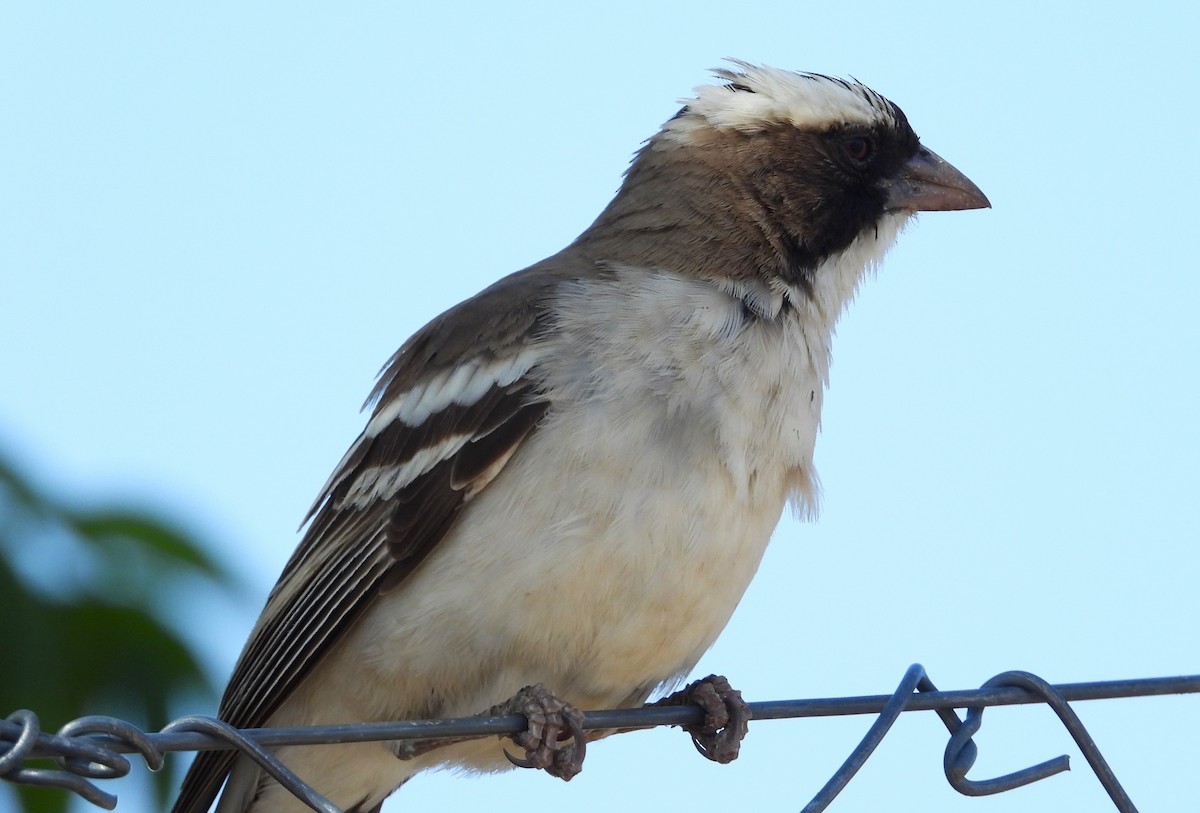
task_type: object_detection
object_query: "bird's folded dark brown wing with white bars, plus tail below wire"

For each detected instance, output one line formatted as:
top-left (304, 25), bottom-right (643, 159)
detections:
top-left (173, 272), bottom-right (553, 813)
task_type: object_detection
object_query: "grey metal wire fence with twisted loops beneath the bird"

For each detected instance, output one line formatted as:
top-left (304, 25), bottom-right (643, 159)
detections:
top-left (0, 664), bottom-right (1200, 813)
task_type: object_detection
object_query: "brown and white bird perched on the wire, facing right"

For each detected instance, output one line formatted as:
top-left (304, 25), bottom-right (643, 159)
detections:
top-left (174, 60), bottom-right (990, 813)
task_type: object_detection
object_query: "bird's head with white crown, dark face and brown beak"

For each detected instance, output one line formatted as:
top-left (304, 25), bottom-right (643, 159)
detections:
top-left (582, 62), bottom-right (990, 297)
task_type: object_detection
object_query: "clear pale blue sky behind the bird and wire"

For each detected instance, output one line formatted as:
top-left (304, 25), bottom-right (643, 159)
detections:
top-left (0, 1), bottom-right (1200, 813)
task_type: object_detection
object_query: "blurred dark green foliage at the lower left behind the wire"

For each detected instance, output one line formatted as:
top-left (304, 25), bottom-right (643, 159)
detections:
top-left (0, 458), bottom-right (236, 813)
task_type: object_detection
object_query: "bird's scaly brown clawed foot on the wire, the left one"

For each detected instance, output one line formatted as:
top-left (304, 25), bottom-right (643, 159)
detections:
top-left (488, 683), bottom-right (587, 782)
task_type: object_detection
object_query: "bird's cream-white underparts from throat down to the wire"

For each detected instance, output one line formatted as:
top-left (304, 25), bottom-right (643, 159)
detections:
top-left (347, 217), bottom-right (904, 717)
